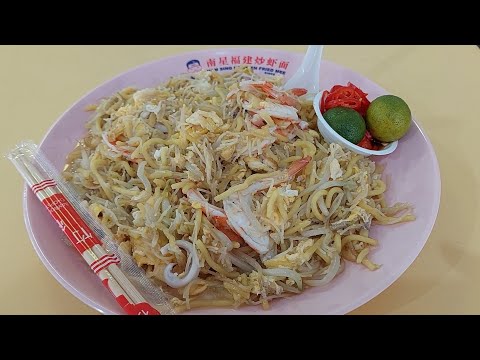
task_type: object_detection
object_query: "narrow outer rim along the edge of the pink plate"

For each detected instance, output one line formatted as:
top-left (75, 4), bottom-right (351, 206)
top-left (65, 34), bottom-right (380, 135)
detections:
top-left (22, 47), bottom-right (442, 315)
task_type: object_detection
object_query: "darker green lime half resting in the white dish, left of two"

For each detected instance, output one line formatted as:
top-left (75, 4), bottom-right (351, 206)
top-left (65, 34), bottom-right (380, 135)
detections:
top-left (323, 107), bottom-right (367, 144)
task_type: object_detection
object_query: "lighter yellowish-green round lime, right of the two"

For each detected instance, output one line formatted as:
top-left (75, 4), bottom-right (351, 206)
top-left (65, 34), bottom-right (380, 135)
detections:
top-left (366, 95), bottom-right (412, 142)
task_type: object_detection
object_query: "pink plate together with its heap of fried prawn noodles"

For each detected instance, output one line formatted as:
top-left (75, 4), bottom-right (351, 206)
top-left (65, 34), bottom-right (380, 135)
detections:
top-left (24, 48), bottom-right (440, 314)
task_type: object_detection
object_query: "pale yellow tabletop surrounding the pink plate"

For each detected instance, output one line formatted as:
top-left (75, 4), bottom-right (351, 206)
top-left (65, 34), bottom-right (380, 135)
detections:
top-left (0, 45), bottom-right (480, 314)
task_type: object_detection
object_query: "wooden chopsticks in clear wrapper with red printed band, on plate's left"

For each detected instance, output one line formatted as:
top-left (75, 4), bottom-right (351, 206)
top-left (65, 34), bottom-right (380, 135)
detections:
top-left (9, 143), bottom-right (164, 315)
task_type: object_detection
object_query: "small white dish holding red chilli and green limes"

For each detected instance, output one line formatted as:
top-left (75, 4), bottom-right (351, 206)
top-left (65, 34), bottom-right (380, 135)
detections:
top-left (313, 91), bottom-right (398, 156)
